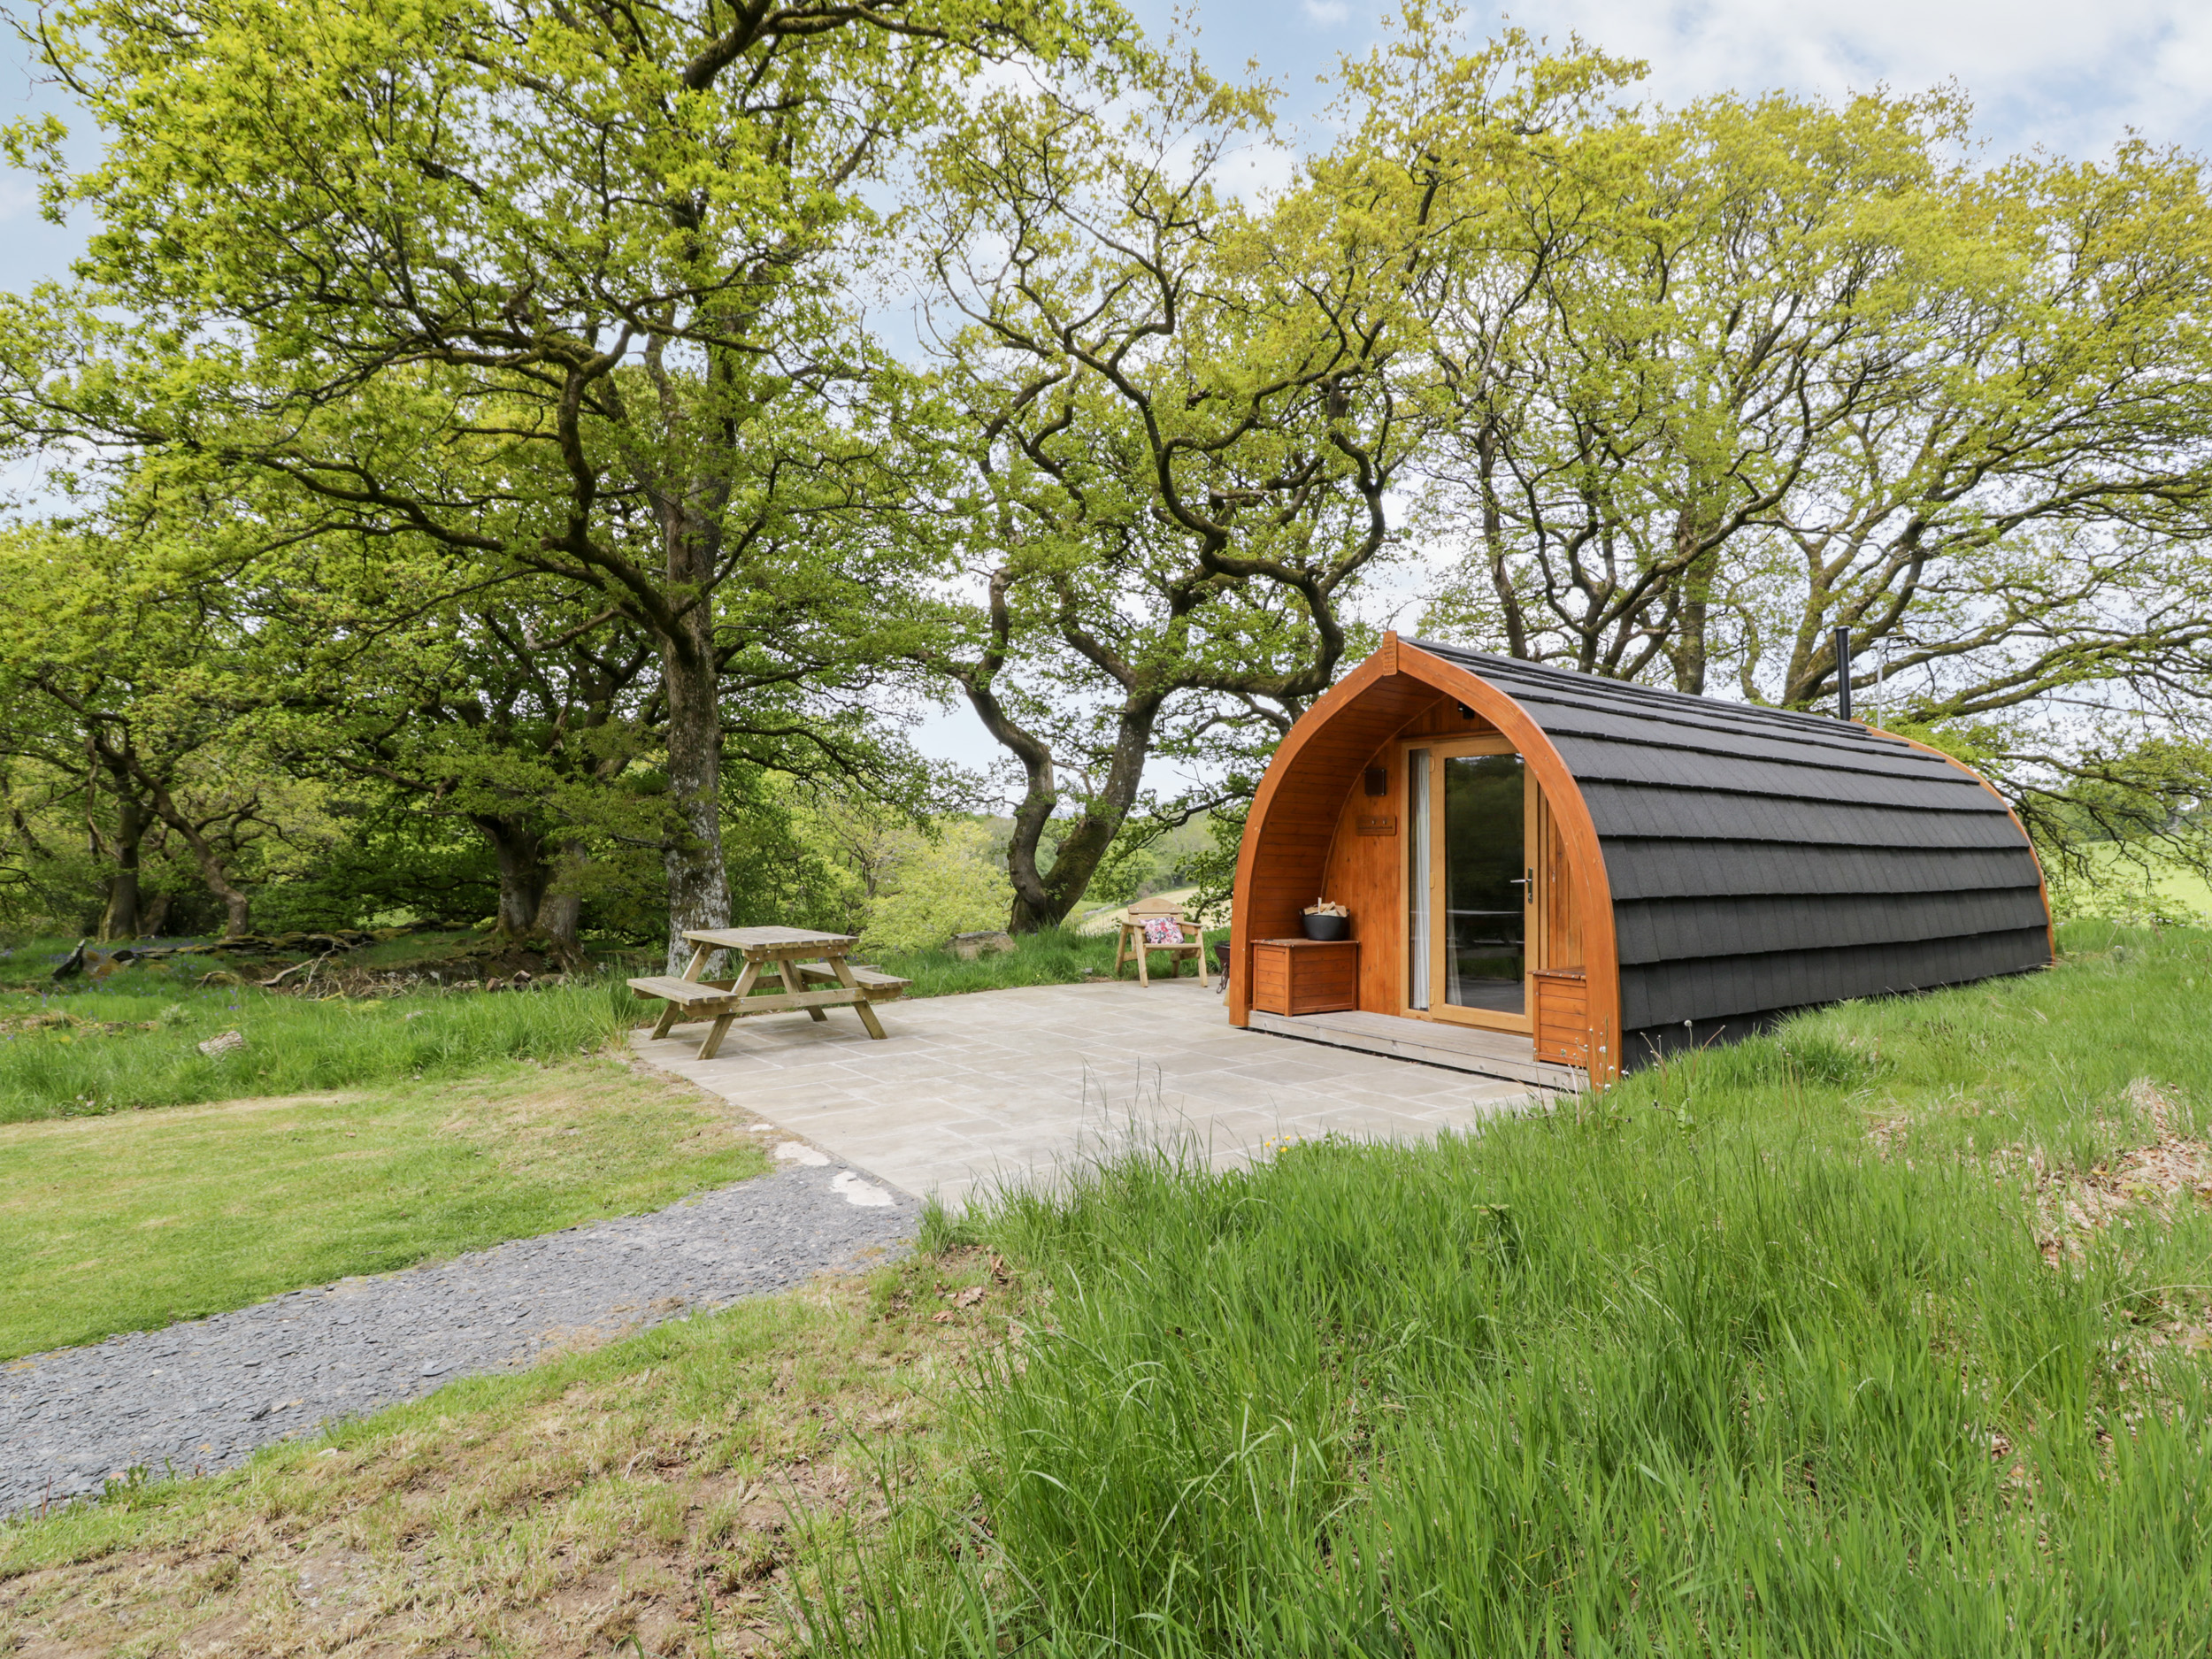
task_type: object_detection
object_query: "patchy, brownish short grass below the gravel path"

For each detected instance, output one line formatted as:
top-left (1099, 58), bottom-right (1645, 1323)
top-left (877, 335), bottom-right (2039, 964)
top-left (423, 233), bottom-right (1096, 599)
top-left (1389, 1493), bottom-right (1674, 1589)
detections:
top-left (0, 1255), bottom-right (1018, 1659)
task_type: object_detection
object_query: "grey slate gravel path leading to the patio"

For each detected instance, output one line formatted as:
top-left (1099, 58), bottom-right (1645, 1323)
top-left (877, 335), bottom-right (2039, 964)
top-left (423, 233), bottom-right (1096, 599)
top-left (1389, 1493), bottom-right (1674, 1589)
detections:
top-left (0, 1141), bottom-right (920, 1516)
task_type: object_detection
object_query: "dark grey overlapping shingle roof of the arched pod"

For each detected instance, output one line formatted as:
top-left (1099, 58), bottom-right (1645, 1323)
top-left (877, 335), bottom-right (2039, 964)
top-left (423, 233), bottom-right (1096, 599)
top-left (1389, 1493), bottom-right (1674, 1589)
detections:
top-left (1407, 640), bottom-right (2051, 1062)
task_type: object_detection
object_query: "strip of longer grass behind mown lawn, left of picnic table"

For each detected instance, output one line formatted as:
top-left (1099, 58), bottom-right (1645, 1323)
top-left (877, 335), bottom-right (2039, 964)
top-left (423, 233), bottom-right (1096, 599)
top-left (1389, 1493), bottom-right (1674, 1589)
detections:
top-left (0, 972), bottom-right (640, 1124)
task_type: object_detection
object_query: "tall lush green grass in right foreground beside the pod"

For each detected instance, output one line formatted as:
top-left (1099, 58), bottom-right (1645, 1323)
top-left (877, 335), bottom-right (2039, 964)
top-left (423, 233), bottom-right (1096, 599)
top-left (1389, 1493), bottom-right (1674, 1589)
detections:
top-left (810, 929), bottom-right (2212, 1659)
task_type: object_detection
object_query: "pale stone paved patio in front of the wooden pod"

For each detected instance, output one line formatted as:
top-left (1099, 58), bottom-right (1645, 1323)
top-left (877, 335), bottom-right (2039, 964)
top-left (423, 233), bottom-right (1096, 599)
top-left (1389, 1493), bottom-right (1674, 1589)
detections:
top-left (633, 980), bottom-right (1529, 1206)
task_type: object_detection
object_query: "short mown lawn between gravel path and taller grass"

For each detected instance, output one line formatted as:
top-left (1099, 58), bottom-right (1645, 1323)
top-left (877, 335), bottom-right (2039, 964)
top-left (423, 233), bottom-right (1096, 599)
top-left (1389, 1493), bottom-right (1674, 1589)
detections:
top-left (0, 1060), bottom-right (768, 1358)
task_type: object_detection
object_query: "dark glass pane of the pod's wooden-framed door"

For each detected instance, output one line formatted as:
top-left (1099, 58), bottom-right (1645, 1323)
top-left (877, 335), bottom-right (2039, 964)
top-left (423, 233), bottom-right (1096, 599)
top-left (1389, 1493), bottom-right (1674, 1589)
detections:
top-left (1436, 755), bottom-right (1529, 1016)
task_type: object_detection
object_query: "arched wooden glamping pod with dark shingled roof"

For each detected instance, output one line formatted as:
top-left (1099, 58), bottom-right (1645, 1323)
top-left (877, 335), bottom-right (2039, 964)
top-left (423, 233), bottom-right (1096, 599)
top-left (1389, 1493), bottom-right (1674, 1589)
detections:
top-left (1230, 635), bottom-right (2053, 1082)
